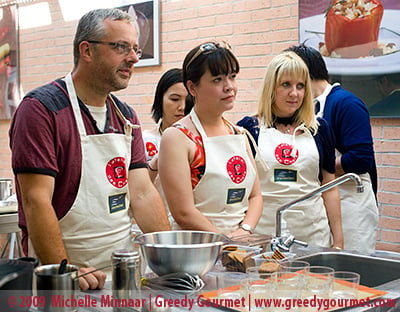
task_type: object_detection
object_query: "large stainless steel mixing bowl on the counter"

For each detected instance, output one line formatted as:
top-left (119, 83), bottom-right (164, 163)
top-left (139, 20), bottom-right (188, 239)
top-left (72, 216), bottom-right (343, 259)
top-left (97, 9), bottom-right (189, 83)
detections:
top-left (134, 231), bottom-right (228, 276)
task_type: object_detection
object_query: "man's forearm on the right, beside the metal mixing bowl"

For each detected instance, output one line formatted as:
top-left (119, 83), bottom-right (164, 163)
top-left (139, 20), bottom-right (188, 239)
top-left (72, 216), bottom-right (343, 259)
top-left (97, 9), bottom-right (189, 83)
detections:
top-left (128, 168), bottom-right (171, 233)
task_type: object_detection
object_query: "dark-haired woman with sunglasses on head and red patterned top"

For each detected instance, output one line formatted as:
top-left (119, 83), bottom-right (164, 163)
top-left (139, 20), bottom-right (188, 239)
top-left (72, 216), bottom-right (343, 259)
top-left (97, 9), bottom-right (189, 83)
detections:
top-left (159, 42), bottom-right (262, 236)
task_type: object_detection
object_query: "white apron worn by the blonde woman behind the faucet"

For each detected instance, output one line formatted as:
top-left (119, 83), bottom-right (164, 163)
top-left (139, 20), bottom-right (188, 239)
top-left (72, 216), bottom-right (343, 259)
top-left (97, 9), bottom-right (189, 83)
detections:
top-left (256, 125), bottom-right (330, 247)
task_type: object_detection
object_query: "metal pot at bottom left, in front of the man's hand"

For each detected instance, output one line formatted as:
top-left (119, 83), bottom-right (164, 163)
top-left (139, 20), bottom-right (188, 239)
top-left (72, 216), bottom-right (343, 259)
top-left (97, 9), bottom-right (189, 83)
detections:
top-left (35, 264), bottom-right (79, 312)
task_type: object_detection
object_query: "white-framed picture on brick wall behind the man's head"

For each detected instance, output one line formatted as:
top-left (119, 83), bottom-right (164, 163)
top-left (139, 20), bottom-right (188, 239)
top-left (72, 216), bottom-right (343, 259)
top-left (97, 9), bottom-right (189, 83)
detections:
top-left (118, 0), bottom-right (160, 67)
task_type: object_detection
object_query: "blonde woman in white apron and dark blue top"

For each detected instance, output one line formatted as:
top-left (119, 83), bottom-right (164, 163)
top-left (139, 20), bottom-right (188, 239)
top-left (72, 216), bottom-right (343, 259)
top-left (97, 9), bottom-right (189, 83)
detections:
top-left (238, 52), bottom-right (343, 248)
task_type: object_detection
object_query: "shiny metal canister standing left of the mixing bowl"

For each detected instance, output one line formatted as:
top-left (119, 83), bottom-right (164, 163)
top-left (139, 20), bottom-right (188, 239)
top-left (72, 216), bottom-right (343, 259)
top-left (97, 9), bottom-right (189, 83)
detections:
top-left (111, 250), bottom-right (141, 311)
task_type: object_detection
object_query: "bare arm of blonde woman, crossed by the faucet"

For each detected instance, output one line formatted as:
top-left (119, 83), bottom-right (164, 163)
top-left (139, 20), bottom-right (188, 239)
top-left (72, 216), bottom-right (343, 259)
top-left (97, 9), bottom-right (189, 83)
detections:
top-left (322, 169), bottom-right (344, 248)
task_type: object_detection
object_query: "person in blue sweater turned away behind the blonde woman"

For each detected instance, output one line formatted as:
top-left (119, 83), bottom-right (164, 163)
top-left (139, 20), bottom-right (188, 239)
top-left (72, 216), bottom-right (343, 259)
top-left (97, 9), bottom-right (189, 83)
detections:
top-left (287, 44), bottom-right (379, 253)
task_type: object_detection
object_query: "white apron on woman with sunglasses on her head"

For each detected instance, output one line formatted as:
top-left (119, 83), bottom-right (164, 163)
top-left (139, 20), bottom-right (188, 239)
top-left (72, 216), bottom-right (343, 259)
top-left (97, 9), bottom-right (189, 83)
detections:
top-left (172, 110), bottom-right (256, 234)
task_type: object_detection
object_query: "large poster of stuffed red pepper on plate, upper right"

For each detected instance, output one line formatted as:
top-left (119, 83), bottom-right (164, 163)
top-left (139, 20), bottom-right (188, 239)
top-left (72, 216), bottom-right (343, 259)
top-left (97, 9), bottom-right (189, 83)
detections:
top-left (299, 0), bottom-right (400, 118)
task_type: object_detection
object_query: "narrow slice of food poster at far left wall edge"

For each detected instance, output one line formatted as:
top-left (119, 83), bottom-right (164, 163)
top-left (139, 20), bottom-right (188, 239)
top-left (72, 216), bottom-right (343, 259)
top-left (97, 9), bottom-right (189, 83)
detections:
top-left (0, 5), bottom-right (20, 119)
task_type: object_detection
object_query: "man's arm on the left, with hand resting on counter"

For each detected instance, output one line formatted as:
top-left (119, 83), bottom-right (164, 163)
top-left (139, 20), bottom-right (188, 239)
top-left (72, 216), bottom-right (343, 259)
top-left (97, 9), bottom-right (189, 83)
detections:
top-left (17, 173), bottom-right (106, 290)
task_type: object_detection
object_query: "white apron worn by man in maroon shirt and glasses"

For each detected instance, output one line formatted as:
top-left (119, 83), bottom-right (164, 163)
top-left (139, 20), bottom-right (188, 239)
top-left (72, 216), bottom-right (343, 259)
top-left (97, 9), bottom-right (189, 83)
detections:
top-left (28, 73), bottom-right (133, 276)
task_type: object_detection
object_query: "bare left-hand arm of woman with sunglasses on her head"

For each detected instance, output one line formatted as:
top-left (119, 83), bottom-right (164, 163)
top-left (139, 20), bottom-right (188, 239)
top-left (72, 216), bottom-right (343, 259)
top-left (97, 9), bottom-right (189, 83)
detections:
top-left (158, 128), bottom-right (219, 232)
